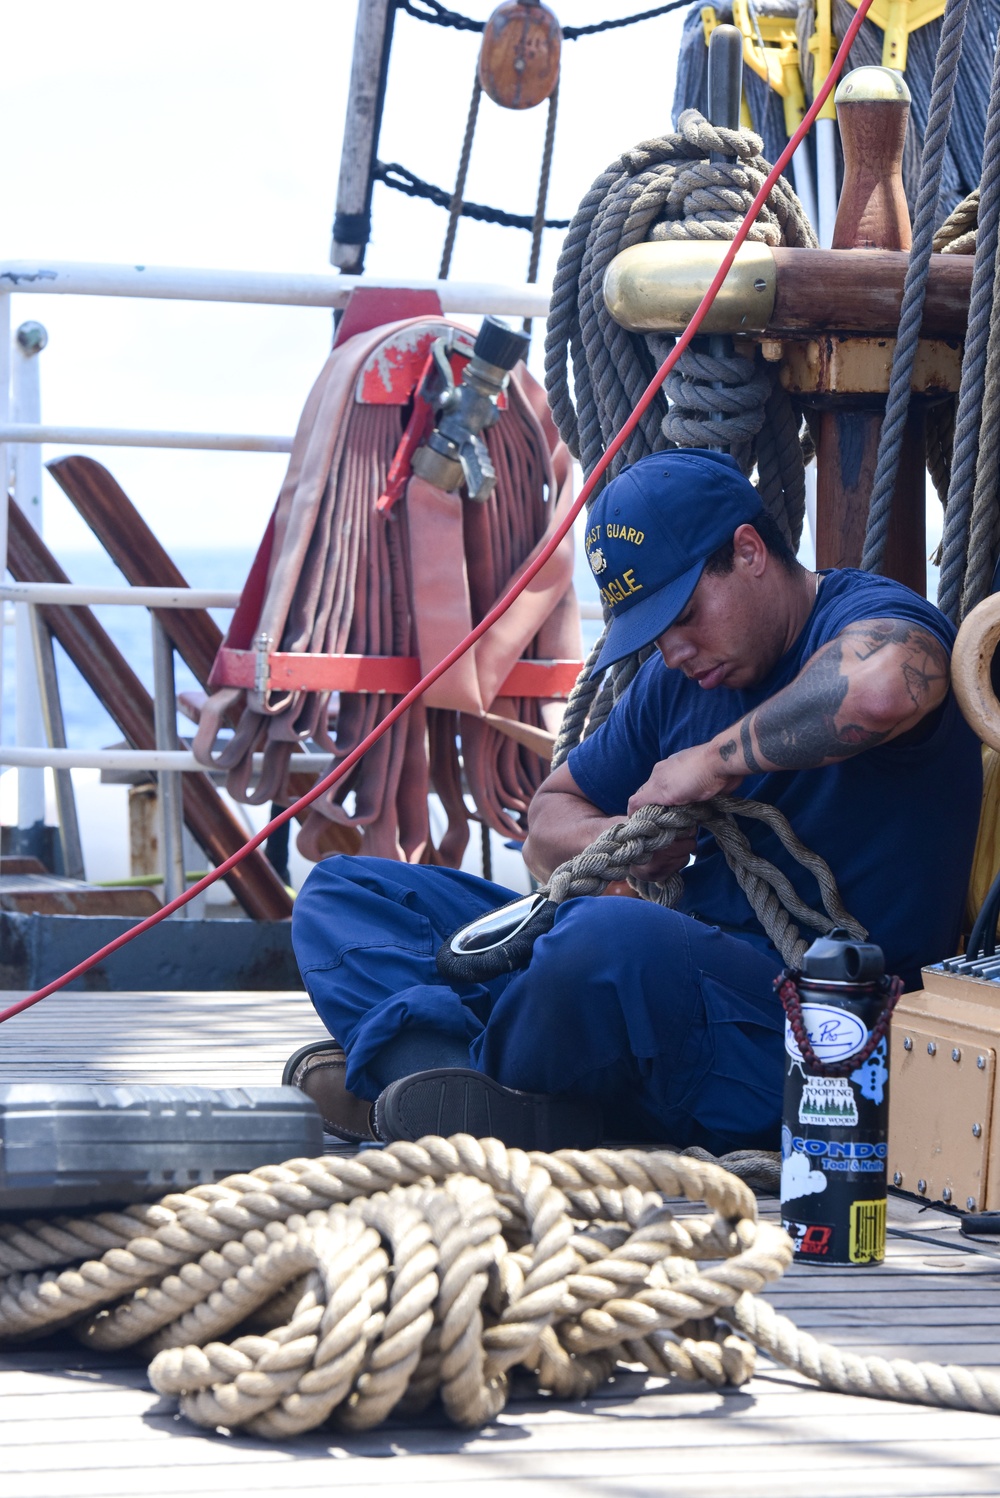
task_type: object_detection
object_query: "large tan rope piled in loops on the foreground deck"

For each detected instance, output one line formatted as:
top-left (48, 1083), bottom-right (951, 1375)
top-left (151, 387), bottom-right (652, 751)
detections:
top-left (0, 1135), bottom-right (1000, 1440)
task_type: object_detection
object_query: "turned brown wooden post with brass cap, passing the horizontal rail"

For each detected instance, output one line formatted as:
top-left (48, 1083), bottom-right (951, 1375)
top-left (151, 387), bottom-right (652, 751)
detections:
top-left (816, 67), bottom-right (927, 593)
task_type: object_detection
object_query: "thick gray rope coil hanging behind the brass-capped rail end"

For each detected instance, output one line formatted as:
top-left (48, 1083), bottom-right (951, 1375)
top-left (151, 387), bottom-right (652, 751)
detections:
top-left (545, 109), bottom-right (816, 767)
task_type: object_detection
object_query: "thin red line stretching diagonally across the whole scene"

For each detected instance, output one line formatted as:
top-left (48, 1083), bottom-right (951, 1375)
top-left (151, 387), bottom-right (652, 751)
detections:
top-left (0, 0), bottom-right (874, 1025)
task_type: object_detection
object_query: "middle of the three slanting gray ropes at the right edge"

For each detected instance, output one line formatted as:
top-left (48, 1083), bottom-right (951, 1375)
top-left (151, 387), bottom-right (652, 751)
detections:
top-left (937, 32), bottom-right (1000, 623)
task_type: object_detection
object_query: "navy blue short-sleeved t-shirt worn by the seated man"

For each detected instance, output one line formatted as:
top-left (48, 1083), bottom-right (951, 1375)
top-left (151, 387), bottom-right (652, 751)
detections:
top-left (567, 569), bottom-right (982, 989)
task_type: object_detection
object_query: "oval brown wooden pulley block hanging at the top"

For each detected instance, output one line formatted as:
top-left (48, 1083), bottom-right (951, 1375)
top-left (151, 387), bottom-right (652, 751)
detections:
top-left (479, 0), bottom-right (563, 109)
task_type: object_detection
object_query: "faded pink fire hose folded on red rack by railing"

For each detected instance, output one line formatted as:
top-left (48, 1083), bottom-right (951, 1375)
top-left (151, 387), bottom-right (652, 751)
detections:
top-left (195, 318), bottom-right (579, 866)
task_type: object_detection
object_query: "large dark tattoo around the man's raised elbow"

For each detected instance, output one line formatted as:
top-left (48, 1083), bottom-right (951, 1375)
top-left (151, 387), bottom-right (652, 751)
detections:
top-left (741, 619), bottom-right (948, 770)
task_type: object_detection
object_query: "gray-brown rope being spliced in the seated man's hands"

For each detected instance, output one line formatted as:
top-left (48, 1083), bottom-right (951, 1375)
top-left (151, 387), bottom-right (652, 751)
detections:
top-left (542, 795), bottom-right (867, 968)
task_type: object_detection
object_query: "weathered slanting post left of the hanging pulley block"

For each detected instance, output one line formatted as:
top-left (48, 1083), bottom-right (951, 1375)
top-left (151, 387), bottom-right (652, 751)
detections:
top-left (329, 0), bottom-right (395, 276)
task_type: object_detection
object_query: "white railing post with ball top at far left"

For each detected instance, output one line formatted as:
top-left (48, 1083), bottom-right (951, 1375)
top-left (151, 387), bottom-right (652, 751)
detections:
top-left (10, 322), bottom-right (48, 860)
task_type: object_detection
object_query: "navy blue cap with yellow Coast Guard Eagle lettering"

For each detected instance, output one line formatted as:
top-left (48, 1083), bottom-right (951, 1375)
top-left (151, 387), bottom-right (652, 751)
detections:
top-left (584, 448), bottom-right (763, 671)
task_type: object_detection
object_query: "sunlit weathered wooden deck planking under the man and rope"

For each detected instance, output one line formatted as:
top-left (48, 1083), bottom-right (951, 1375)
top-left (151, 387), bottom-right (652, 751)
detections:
top-left (0, 993), bottom-right (1000, 1498)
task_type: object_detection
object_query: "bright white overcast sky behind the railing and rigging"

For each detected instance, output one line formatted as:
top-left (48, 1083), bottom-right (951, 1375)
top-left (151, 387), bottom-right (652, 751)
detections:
top-left (0, 0), bottom-right (684, 553)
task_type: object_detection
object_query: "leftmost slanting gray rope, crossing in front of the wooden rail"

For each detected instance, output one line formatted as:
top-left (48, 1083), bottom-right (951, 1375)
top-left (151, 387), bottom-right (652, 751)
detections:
top-left (861, 0), bottom-right (970, 572)
